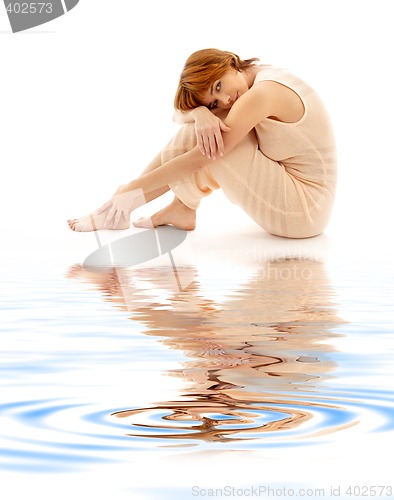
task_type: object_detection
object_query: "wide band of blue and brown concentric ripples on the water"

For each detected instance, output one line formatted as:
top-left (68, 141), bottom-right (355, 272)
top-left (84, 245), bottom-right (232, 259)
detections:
top-left (0, 390), bottom-right (394, 472)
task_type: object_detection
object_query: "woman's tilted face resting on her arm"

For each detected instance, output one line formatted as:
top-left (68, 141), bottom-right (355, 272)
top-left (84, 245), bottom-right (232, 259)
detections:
top-left (202, 69), bottom-right (249, 109)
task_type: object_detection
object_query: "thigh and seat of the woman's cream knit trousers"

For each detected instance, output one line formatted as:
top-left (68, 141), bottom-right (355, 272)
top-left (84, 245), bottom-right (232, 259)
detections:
top-left (210, 130), bottom-right (333, 238)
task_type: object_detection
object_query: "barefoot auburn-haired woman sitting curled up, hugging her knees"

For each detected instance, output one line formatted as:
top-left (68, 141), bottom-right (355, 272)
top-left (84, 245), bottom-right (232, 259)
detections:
top-left (69, 49), bottom-right (336, 238)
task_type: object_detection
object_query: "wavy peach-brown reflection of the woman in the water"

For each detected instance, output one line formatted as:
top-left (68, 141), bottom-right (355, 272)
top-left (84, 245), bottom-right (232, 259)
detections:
top-left (70, 259), bottom-right (355, 442)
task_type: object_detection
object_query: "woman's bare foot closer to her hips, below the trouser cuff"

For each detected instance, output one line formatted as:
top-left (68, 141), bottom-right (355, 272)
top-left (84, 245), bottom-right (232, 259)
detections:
top-left (133, 198), bottom-right (196, 231)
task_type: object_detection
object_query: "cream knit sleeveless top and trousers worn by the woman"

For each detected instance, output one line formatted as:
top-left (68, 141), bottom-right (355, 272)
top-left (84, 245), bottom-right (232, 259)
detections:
top-left (161, 66), bottom-right (336, 238)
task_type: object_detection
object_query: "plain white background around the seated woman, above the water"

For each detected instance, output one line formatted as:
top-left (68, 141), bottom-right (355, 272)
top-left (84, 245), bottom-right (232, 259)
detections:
top-left (0, 0), bottom-right (394, 270)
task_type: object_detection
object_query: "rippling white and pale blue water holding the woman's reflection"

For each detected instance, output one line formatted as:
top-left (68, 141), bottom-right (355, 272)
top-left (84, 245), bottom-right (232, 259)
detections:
top-left (0, 259), bottom-right (394, 472)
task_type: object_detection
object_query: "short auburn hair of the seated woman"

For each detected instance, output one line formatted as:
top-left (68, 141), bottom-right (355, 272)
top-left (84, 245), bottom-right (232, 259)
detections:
top-left (174, 49), bottom-right (259, 111)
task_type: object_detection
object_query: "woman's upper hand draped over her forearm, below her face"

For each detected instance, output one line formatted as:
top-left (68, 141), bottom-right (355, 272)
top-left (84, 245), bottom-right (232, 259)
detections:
top-left (193, 106), bottom-right (231, 160)
